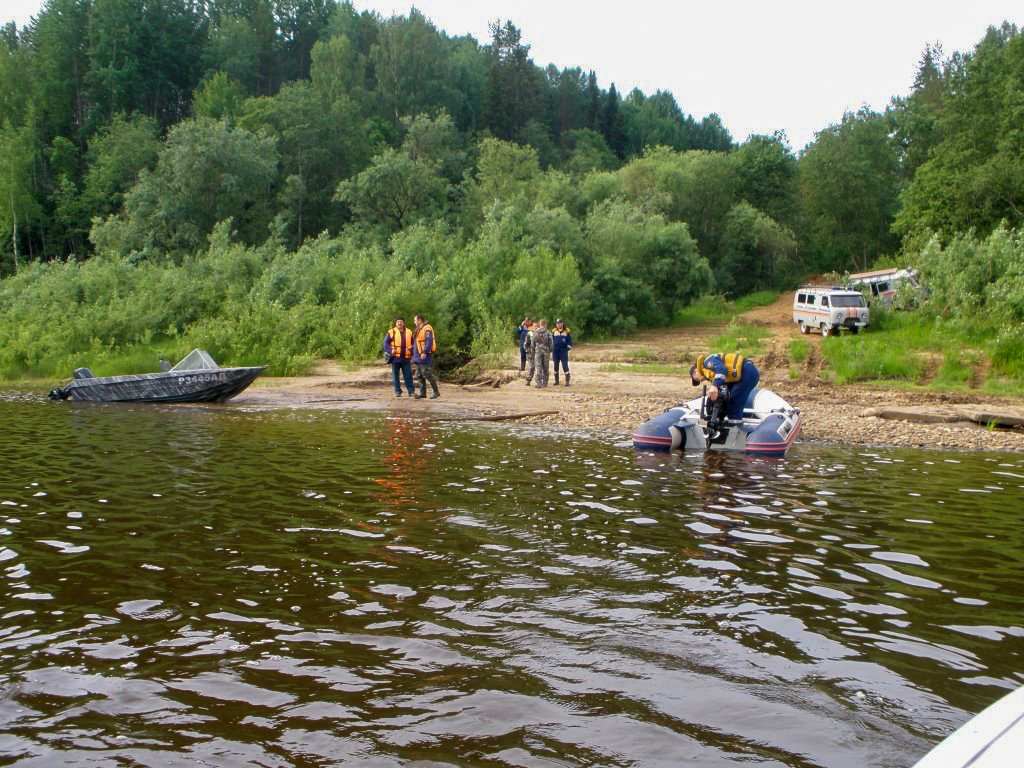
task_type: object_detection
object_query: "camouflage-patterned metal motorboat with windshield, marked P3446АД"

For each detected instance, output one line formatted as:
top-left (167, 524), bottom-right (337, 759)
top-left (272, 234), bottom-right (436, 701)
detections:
top-left (49, 349), bottom-right (266, 402)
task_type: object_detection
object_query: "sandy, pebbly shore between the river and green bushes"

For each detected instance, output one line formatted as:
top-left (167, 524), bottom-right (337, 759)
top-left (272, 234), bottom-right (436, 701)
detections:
top-left (234, 297), bottom-right (1024, 452)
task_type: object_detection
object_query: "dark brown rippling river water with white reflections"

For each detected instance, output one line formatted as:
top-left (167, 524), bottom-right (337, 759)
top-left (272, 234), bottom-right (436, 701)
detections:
top-left (0, 392), bottom-right (1024, 768)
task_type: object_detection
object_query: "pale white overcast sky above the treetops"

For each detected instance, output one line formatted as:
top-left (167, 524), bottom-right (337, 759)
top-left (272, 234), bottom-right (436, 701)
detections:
top-left (0, 0), bottom-right (1024, 151)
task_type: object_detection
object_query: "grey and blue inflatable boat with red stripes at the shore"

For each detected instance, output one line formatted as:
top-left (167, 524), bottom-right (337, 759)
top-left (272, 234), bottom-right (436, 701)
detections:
top-left (633, 389), bottom-right (801, 456)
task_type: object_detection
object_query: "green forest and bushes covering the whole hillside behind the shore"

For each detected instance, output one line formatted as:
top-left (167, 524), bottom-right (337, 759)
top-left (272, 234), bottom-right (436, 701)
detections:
top-left (0, 0), bottom-right (1024, 377)
